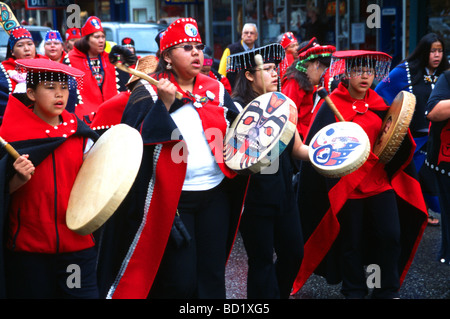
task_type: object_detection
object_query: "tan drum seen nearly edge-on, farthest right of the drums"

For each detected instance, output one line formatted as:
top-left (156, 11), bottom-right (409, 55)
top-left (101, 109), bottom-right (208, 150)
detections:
top-left (373, 91), bottom-right (416, 164)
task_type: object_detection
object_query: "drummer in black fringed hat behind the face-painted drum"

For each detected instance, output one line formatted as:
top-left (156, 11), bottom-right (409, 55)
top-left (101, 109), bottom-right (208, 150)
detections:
top-left (227, 43), bottom-right (308, 299)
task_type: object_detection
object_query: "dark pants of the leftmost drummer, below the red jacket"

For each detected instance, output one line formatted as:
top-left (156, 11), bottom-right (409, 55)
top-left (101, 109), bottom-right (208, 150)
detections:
top-left (5, 248), bottom-right (99, 299)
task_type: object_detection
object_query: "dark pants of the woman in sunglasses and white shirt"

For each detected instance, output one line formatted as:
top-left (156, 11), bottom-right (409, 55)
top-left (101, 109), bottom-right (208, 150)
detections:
top-left (148, 183), bottom-right (230, 299)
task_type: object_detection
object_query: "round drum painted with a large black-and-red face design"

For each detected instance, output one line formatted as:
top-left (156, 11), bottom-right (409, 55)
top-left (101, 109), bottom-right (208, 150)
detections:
top-left (224, 92), bottom-right (297, 175)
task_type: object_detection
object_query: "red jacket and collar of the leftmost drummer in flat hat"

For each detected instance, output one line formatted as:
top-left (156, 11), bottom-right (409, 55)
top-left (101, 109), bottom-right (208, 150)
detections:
top-left (0, 95), bottom-right (94, 254)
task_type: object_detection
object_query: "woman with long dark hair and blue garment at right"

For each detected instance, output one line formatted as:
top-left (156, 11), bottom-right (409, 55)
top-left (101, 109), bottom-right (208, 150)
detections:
top-left (375, 33), bottom-right (450, 226)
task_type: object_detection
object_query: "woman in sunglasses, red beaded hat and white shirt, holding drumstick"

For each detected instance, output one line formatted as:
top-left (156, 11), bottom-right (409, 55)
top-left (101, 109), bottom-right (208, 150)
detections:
top-left (99, 18), bottom-right (246, 299)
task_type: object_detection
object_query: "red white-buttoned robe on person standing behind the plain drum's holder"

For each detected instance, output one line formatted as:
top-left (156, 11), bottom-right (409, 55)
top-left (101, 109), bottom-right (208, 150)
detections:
top-left (64, 47), bottom-right (119, 122)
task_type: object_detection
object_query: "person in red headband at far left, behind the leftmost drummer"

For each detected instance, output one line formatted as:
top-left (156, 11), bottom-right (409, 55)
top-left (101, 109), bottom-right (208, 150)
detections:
top-left (0, 26), bottom-right (47, 125)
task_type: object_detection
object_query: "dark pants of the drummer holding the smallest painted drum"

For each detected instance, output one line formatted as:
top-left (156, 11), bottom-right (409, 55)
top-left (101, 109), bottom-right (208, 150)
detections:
top-left (339, 191), bottom-right (401, 298)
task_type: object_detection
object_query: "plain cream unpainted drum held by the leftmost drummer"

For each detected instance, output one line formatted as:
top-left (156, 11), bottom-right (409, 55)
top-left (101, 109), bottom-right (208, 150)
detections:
top-left (66, 124), bottom-right (143, 235)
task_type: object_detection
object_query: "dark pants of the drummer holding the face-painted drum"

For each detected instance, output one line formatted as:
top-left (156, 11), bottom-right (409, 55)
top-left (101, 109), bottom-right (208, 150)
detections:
top-left (240, 204), bottom-right (303, 299)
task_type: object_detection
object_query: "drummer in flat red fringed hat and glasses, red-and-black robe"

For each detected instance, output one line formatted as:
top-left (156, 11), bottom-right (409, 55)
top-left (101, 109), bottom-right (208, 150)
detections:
top-left (294, 51), bottom-right (427, 298)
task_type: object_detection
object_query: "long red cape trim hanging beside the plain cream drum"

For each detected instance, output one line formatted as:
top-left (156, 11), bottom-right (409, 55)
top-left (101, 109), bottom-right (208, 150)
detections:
top-left (112, 141), bottom-right (187, 299)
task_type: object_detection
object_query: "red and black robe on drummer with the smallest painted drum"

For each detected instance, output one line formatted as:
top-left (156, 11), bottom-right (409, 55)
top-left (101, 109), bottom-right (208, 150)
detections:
top-left (293, 83), bottom-right (427, 293)
